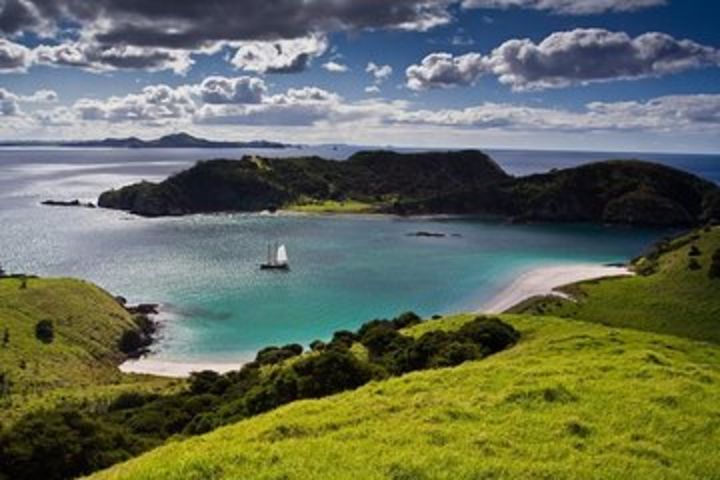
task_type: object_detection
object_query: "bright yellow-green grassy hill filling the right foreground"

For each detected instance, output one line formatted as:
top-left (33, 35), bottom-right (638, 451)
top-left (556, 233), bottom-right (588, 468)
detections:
top-left (94, 316), bottom-right (720, 480)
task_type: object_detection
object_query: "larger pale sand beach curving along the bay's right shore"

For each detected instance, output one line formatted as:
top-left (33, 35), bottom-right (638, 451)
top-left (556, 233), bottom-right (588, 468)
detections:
top-left (478, 264), bottom-right (633, 313)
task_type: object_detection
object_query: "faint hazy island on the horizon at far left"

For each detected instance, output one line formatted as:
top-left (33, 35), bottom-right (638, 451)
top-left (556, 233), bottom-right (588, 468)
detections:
top-left (0, 132), bottom-right (291, 148)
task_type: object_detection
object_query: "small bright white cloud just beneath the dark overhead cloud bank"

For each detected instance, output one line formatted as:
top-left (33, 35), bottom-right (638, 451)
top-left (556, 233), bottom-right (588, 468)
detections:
top-left (230, 35), bottom-right (328, 73)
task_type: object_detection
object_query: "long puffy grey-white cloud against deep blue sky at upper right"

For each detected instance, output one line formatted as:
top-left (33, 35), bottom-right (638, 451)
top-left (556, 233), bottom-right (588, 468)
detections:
top-left (406, 28), bottom-right (720, 90)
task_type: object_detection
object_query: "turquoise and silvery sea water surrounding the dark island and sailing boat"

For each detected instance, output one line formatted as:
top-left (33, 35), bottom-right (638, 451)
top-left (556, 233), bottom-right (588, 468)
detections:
top-left (0, 146), bottom-right (720, 362)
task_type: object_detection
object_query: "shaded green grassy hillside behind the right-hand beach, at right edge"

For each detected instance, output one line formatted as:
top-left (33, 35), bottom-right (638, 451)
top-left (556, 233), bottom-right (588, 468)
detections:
top-left (512, 227), bottom-right (720, 343)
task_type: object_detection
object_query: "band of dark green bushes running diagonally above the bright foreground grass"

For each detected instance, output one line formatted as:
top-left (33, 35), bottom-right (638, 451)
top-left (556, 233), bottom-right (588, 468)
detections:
top-left (0, 313), bottom-right (520, 480)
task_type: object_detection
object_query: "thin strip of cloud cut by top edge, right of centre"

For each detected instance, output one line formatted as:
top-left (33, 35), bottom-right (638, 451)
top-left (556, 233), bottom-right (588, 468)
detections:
top-left (462, 0), bottom-right (667, 15)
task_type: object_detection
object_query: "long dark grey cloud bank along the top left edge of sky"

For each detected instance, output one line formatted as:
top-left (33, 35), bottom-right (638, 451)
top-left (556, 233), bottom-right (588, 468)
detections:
top-left (0, 0), bottom-right (455, 49)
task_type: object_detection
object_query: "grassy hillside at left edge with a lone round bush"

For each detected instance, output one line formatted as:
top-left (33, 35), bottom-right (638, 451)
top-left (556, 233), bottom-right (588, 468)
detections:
top-left (0, 278), bottom-right (176, 425)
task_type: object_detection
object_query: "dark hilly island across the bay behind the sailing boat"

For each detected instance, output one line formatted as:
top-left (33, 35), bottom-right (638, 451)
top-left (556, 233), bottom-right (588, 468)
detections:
top-left (98, 150), bottom-right (720, 226)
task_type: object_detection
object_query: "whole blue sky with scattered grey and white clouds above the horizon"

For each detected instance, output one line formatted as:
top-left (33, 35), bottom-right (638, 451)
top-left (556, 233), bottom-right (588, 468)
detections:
top-left (0, 0), bottom-right (720, 153)
